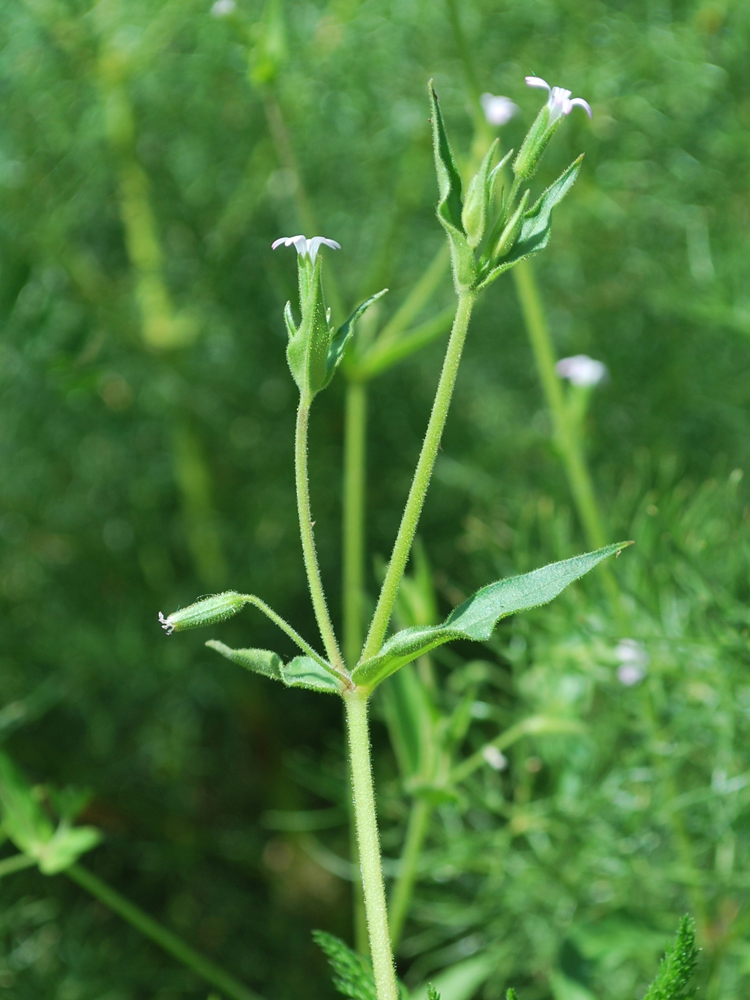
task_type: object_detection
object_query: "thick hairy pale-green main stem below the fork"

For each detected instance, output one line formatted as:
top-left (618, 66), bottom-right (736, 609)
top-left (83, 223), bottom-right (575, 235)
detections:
top-left (344, 692), bottom-right (398, 1000)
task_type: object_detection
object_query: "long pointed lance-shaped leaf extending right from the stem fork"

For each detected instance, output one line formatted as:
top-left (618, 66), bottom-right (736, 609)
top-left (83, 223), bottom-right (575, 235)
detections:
top-left (352, 542), bottom-right (631, 690)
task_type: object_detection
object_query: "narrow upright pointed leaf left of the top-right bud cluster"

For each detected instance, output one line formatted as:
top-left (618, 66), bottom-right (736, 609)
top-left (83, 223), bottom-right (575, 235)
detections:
top-left (429, 80), bottom-right (476, 293)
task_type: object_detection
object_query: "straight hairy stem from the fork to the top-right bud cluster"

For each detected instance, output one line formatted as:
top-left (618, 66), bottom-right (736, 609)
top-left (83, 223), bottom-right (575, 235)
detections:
top-left (362, 292), bottom-right (476, 660)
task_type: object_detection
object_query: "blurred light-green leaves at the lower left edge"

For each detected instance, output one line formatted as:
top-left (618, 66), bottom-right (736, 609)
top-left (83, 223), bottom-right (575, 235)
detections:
top-left (0, 752), bottom-right (102, 875)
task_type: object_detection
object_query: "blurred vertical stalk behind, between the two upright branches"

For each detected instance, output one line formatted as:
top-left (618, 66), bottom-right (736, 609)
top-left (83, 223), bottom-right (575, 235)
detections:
top-left (342, 381), bottom-right (367, 667)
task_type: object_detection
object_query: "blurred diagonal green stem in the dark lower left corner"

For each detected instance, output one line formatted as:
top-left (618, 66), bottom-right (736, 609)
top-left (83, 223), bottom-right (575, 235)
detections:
top-left (65, 865), bottom-right (262, 1000)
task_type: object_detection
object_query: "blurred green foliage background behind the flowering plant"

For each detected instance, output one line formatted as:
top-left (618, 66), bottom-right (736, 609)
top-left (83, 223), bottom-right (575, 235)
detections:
top-left (0, 0), bottom-right (750, 1000)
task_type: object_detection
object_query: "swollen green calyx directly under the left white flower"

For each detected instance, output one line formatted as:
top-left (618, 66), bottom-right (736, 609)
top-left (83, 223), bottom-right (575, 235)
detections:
top-left (285, 254), bottom-right (333, 397)
